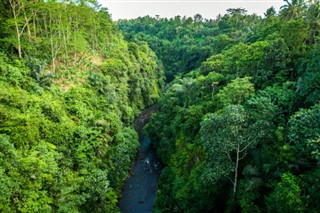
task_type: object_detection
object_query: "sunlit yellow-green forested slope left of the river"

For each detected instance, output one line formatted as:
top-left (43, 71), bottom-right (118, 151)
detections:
top-left (0, 0), bottom-right (163, 212)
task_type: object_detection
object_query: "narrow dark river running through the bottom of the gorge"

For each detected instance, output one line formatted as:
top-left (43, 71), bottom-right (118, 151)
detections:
top-left (119, 107), bottom-right (161, 213)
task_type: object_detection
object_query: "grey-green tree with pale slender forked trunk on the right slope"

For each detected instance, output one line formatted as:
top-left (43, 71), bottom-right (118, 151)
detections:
top-left (200, 105), bottom-right (269, 198)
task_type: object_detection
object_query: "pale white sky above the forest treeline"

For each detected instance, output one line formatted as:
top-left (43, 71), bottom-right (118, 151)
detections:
top-left (99, 0), bottom-right (285, 20)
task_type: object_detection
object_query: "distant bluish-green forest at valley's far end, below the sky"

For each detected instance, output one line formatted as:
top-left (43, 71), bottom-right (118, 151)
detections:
top-left (118, 11), bottom-right (258, 81)
